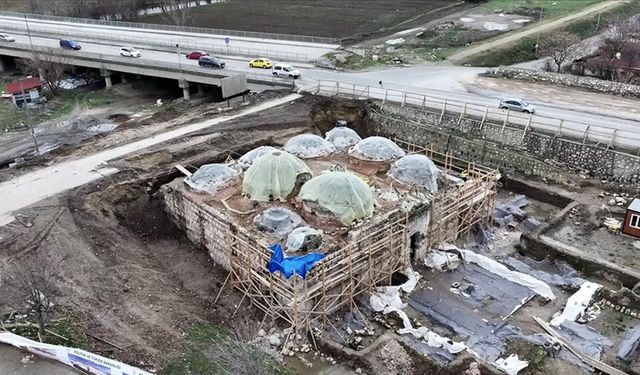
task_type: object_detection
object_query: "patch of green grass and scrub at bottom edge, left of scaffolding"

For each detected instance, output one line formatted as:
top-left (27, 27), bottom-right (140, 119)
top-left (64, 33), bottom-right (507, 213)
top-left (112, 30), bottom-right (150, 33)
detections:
top-left (160, 323), bottom-right (293, 375)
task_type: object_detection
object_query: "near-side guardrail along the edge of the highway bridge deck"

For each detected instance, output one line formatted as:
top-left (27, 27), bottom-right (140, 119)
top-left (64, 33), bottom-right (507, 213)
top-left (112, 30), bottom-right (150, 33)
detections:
top-left (0, 43), bottom-right (292, 87)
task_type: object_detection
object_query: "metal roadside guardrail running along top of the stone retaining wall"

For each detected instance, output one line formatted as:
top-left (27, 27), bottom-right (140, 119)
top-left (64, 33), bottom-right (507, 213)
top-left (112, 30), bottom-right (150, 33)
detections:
top-left (307, 80), bottom-right (640, 151)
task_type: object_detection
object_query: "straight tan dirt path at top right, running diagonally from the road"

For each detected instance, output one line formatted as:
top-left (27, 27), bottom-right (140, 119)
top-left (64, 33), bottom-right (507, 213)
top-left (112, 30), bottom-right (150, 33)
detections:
top-left (449, 0), bottom-right (624, 62)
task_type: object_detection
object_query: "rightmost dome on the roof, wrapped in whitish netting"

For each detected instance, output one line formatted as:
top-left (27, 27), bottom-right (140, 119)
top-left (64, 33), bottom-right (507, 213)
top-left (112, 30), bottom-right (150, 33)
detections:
top-left (387, 155), bottom-right (438, 193)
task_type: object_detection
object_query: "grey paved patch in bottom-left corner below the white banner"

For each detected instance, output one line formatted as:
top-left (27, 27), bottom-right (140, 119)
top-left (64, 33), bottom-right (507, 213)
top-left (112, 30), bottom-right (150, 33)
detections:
top-left (0, 344), bottom-right (78, 375)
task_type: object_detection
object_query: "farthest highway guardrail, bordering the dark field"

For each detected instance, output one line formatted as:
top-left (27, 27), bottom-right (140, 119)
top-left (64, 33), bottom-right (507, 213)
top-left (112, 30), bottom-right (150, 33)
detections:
top-left (0, 11), bottom-right (340, 44)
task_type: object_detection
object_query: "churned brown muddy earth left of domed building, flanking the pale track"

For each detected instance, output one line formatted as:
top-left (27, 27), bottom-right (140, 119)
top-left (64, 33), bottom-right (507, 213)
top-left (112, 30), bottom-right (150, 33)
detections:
top-left (0, 93), bottom-right (322, 369)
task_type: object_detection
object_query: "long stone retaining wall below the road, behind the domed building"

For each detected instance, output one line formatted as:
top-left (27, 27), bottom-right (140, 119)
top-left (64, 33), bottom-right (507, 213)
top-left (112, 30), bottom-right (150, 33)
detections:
top-left (378, 104), bottom-right (640, 184)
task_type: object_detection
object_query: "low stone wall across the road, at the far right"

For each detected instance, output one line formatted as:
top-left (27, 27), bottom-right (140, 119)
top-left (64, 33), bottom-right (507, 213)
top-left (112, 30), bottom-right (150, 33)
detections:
top-left (487, 66), bottom-right (640, 97)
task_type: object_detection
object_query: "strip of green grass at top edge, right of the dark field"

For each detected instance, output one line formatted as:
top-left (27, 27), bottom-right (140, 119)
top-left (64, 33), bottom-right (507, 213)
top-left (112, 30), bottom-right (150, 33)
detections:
top-left (482, 0), bottom-right (604, 20)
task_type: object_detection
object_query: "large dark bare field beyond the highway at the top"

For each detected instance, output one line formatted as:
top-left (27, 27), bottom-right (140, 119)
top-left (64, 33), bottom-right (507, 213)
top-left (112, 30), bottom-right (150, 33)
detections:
top-left (143, 0), bottom-right (468, 38)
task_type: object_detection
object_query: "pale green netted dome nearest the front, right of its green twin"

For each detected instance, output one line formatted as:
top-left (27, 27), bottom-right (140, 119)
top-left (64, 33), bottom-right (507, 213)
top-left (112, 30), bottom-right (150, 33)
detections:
top-left (299, 171), bottom-right (374, 225)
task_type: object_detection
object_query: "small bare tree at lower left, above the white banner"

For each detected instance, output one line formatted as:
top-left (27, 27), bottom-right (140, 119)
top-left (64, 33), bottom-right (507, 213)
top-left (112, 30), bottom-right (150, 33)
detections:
top-left (5, 256), bottom-right (58, 341)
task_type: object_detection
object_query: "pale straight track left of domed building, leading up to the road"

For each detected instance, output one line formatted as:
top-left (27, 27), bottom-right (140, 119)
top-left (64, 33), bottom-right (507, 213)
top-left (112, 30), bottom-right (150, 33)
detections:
top-left (0, 94), bottom-right (301, 226)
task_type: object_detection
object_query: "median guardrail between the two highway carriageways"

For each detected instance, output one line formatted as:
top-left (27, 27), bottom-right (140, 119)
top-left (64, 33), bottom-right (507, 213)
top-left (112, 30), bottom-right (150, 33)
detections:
top-left (2, 25), bottom-right (309, 62)
